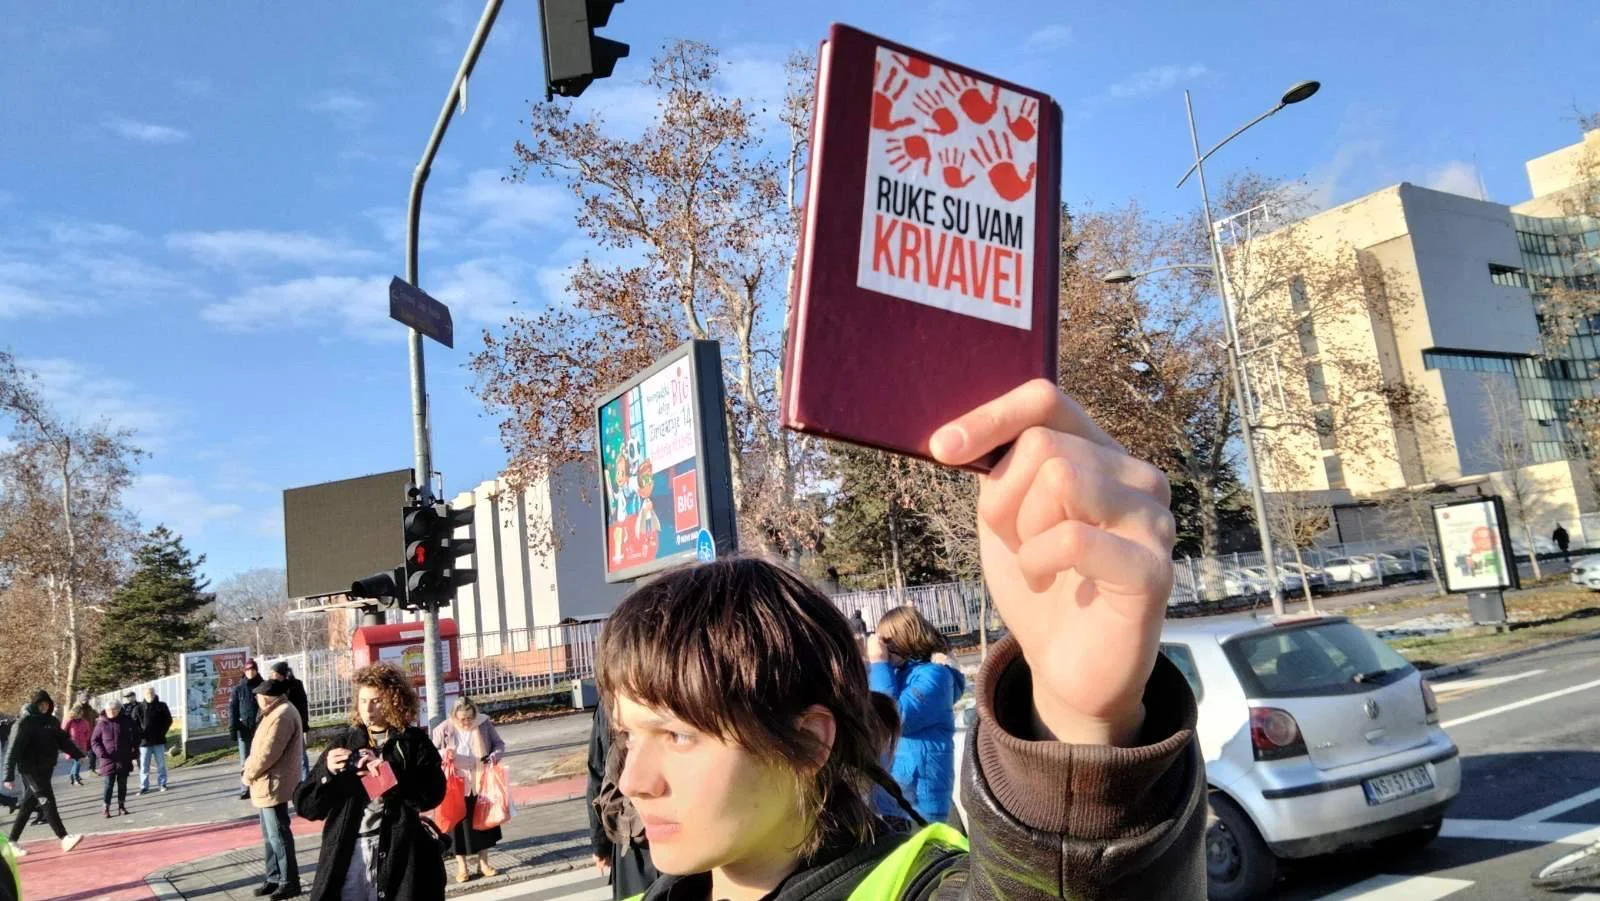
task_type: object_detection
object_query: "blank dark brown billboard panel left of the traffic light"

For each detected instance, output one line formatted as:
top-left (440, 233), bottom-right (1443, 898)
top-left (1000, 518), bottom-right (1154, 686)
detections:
top-left (283, 469), bottom-right (411, 597)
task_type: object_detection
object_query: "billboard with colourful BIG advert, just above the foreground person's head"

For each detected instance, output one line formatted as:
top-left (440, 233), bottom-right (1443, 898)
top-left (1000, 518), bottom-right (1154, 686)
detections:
top-left (594, 341), bottom-right (738, 583)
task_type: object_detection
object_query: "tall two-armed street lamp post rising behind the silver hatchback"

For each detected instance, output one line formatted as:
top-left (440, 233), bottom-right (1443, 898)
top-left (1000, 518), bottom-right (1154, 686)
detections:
top-left (1102, 82), bottom-right (1322, 615)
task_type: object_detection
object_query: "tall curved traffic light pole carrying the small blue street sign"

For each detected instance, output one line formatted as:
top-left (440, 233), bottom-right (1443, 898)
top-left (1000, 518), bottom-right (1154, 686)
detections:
top-left (405, 0), bottom-right (502, 728)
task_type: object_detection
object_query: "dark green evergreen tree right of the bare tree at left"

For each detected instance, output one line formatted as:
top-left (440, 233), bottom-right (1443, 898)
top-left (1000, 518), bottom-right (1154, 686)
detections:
top-left (85, 527), bottom-right (216, 691)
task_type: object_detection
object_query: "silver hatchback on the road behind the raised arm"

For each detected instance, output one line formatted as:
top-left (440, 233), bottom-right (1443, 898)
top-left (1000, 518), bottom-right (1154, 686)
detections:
top-left (1162, 616), bottom-right (1461, 901)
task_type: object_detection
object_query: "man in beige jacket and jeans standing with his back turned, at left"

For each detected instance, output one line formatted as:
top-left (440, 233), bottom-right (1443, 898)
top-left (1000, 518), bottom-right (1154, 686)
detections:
top-left (240, 679), bottom-right (306, 901)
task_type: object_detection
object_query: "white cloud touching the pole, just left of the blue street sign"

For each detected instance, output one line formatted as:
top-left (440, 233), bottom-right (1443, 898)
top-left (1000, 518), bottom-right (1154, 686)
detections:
top-left (200, 275), bottom-right (400, 338)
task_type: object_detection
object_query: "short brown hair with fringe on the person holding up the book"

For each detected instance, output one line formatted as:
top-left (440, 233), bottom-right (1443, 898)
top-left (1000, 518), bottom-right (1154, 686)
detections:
top-left (595, 557), bottom-right (928, 856)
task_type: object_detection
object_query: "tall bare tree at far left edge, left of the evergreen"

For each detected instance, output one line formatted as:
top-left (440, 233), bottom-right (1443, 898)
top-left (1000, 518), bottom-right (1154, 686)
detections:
top-left (0, 350), bottom-right (141, 698)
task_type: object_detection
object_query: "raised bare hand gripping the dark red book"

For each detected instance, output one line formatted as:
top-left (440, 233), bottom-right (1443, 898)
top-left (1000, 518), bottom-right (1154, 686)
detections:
top-left (931, 379), bottom-right (1176, 744)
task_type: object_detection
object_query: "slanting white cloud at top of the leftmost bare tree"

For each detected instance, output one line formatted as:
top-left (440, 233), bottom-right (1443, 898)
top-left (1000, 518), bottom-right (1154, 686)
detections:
top-left (18, 357), bottom-right (184, 450)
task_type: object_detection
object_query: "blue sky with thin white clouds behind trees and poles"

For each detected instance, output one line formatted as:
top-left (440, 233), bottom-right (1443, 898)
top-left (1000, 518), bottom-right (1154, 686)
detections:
top-left (0, 0), bottom-right (1600, 579)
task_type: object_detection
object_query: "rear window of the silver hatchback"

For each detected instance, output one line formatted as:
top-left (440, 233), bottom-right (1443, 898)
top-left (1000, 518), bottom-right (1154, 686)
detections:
top-left (1222, 623), bottom-right (1413, 698)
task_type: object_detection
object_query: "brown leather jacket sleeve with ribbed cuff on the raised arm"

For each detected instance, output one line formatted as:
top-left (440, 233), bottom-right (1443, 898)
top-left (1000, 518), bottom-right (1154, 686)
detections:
top-left (962, 639), bottom-right (1206, 901)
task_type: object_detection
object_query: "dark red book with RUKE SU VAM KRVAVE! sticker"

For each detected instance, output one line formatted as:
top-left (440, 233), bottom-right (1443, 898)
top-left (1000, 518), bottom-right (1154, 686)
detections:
top-left (782, 24), bottom-right (1061, 469)
